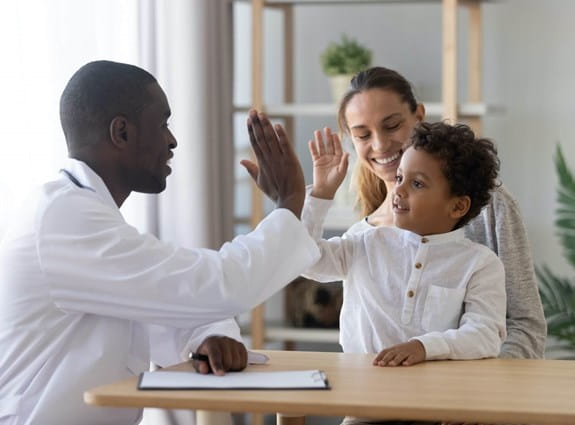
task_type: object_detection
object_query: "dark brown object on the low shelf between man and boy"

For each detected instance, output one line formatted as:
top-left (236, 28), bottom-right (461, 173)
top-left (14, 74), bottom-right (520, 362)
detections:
top-left (285, 277), bottom-right (343, 328)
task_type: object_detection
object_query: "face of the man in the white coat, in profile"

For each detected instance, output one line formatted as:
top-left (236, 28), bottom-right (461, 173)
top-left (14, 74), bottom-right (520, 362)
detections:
top-left (128, 84), bottom-right (178, 193)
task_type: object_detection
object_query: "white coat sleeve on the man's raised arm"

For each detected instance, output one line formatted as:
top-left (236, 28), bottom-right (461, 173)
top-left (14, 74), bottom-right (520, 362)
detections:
top-left (37, 190), bottom-right (319, 328)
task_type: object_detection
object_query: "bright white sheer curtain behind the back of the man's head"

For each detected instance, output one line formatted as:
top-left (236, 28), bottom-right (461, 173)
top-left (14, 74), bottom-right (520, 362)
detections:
top-left (0, 0), bottom-right (139, 238)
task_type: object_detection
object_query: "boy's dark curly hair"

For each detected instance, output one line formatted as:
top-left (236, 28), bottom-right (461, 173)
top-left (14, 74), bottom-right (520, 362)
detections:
top-left (410, 122), bottom-right (499, 229)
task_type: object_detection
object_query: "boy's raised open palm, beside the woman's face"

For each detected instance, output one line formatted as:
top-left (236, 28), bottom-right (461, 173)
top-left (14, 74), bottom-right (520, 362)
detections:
top-left (308, 127), bottom-right (349, 199)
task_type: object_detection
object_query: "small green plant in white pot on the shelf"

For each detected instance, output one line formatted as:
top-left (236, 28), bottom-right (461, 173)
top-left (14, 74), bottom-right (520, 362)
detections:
top-left (321, 34), bottom-right (371, 102)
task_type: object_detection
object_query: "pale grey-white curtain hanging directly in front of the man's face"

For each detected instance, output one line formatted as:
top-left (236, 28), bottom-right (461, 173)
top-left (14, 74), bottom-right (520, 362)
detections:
top-left (135, 0), bottom-right (233, 425)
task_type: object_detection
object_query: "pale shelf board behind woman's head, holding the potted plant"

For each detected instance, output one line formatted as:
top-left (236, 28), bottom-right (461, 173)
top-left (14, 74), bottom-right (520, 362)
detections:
top-left (234, 102), bottom-right (501, 118)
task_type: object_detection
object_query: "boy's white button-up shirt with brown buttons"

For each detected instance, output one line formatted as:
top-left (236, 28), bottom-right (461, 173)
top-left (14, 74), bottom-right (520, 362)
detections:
top-left (302, 196), bottom-right (506, 360)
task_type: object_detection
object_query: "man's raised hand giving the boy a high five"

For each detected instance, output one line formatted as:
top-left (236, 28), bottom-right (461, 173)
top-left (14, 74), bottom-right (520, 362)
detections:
top-left (240, 110), bottom-right (305, 218)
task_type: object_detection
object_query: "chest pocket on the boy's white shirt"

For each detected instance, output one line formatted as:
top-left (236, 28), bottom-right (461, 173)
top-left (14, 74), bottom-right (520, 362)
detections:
top-left (421, 285), bottom-right (466, 332)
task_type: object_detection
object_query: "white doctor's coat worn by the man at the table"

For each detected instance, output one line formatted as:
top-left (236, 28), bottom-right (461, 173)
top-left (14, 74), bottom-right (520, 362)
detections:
top-left (0, 160), bottom-right (318, 425)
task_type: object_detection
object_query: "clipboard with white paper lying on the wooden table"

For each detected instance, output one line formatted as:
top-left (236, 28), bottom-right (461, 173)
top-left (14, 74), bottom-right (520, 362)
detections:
top-left (138, 369), bottom-right (330, 390)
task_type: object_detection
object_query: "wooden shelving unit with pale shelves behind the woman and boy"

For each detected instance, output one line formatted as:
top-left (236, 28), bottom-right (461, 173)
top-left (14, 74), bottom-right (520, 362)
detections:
top-left (235, 0), bottom-right (489, 349)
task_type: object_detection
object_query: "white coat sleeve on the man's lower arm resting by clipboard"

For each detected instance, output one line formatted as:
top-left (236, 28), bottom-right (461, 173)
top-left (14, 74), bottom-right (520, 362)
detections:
top-left (148, 319), bottom-right (243, 367)
